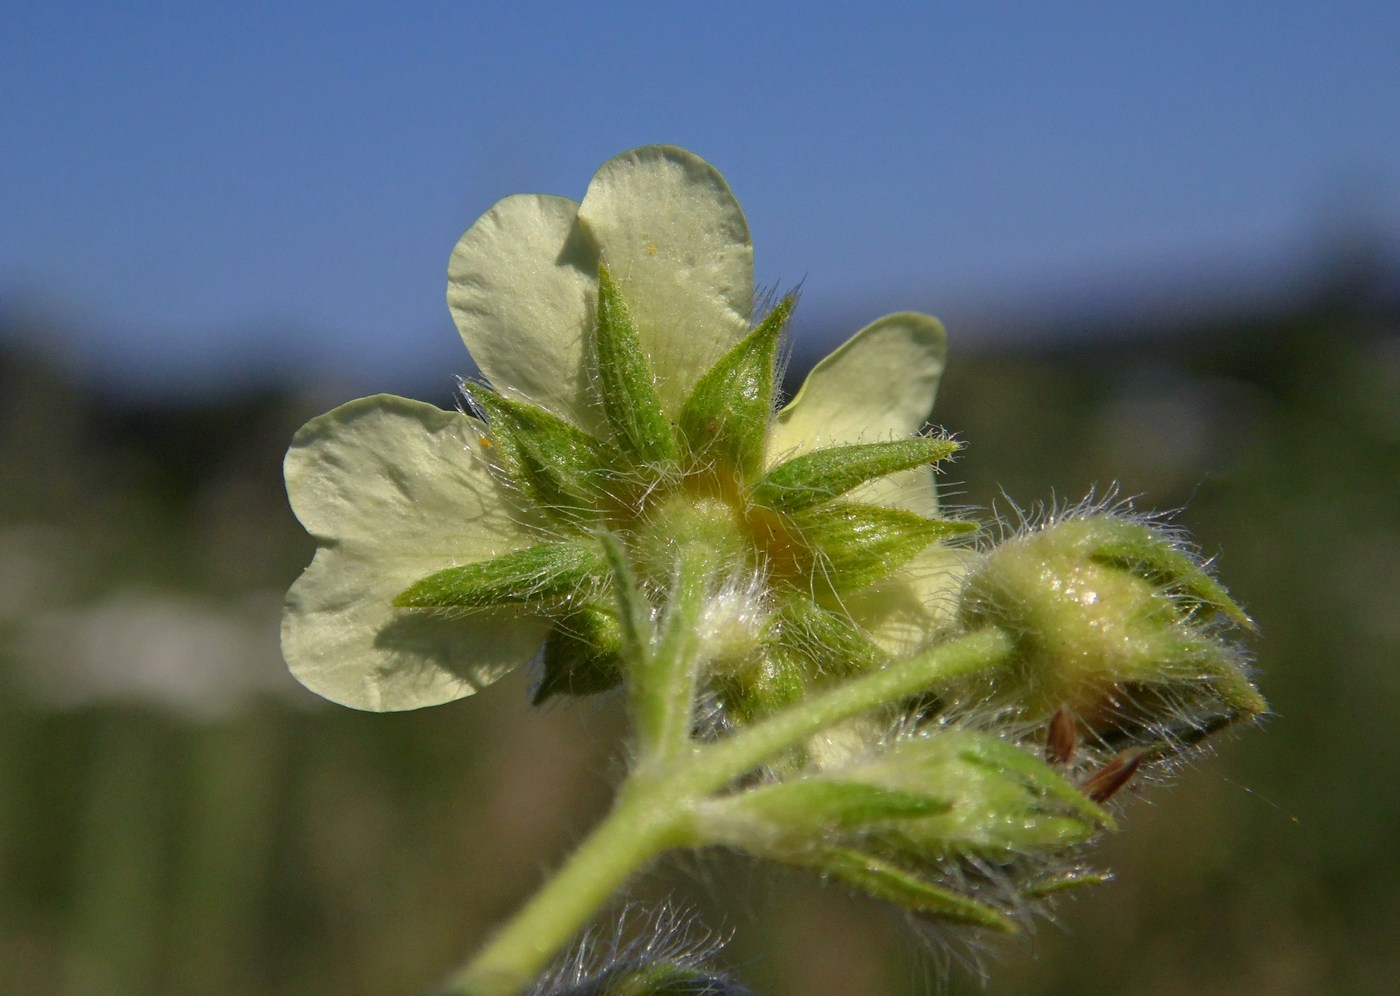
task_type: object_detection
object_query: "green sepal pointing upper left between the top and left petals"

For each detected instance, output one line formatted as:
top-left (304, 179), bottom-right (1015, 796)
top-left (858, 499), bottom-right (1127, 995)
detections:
top-left (468, 385), bottom-right (622, 524)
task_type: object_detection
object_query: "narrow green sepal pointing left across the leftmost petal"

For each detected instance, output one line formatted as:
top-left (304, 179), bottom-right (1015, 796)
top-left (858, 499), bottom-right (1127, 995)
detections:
top-left (393, 544), bottom-right (608, 609)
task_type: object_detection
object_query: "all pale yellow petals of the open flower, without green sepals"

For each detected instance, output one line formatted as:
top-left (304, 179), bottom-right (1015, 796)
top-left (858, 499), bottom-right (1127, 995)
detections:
top-left (283, 146), bottom-right (958, 710)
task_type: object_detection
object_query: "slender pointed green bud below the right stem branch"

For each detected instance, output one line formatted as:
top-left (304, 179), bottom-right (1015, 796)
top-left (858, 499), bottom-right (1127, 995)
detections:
top-left (696, 728), bottom-right (1112, 930)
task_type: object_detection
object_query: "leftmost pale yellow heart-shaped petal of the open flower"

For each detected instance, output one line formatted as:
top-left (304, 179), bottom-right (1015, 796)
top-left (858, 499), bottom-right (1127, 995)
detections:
top-left (281, 395), bottom-right (546, 710)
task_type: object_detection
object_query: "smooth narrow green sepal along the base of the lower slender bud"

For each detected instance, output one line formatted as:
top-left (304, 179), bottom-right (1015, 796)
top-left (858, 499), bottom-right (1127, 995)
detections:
top-left (725, 776), bottom-right (949, 836)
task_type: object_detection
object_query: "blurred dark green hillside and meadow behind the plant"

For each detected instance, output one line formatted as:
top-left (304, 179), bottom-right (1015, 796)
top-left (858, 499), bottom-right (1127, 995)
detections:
top-left (0, 259), bottom-right (1400, 996)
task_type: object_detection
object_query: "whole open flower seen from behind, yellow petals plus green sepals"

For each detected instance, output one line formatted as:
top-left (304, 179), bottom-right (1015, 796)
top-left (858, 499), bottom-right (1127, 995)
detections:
top-left (283, 146), bottom-right (970, 713)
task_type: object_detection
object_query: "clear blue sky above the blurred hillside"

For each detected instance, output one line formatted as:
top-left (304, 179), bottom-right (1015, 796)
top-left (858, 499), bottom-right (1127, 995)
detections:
top-left (0, 0), bottom-right (1400, 389)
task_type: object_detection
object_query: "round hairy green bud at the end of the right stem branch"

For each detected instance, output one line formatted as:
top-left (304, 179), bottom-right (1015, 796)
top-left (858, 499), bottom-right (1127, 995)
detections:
top-left (951, 513), bottom-right (1267, 733)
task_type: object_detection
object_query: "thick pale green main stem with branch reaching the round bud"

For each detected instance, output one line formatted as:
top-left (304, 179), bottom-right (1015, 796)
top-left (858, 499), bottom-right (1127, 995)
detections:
top-left (442, 629), bottom-right (1014, 996)
